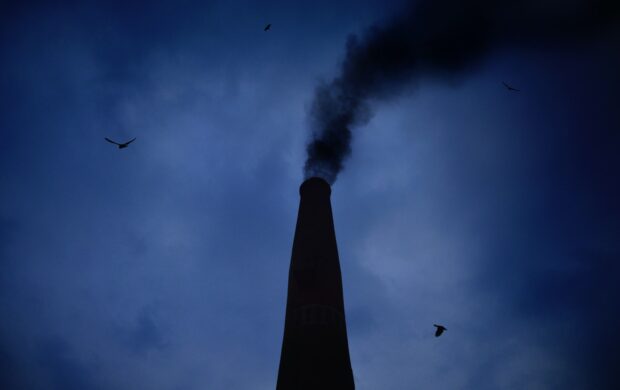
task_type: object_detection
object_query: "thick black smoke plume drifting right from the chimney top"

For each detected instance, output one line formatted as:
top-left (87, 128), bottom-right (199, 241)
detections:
top-left (304, 0), bottom-right (620, 183)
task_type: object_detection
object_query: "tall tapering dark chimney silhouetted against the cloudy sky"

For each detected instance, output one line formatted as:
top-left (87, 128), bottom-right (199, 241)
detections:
top-left (276, 177), bottom-right (355, 390)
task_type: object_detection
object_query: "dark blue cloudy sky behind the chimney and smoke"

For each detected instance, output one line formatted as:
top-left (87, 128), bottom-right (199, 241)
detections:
top-left (0, 0), bottom-right (620, 390)
